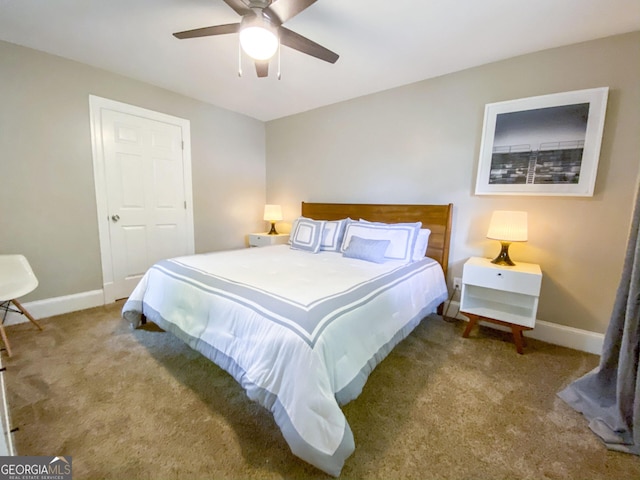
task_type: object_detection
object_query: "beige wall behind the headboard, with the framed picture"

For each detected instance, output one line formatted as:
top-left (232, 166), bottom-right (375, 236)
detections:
top-left (267, 32), bottom-right (640, 333)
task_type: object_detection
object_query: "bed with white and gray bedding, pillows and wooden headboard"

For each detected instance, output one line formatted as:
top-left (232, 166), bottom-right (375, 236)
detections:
top-left (122, 202), bottom-right (452, 476)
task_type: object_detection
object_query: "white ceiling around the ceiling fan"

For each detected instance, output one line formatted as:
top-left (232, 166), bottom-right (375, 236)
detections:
top-left (0, 0), bottom-right (640, 121)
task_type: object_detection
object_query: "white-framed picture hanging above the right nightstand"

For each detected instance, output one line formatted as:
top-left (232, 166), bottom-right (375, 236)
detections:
top-left (475, 87), bottom-right (609, 197)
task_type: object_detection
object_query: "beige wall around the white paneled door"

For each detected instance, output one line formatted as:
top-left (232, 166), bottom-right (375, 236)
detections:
top-left (0, 42), bottom-right (265, 301)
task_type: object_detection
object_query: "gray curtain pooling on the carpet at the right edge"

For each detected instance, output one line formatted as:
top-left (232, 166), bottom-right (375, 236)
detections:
top-left (558, 180), bottom-right (640, 455)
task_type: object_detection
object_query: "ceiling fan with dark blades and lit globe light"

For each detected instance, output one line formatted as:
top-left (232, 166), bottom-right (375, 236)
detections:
top-left (173, 0), bottom-right (338, 77)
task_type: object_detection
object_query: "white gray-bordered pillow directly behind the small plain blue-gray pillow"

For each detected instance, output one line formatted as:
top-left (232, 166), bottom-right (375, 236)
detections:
top-left (341, 221), bottom-right (422, 262)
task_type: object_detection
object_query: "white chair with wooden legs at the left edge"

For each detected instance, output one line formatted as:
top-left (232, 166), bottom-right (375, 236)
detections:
top-left (0, 255), bottom-right (42, 356)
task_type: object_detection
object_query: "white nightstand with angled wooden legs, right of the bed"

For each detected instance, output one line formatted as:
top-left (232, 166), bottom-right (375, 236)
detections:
top-left (460, 257), bottom-right (542, 353)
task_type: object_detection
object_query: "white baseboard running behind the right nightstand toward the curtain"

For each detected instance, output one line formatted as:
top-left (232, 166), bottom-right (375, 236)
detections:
top-left (445, 301), bottom-right (604, 355)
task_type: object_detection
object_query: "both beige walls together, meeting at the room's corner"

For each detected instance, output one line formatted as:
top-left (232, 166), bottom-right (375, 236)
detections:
top-left (0, 32), bottom-right (640, 332)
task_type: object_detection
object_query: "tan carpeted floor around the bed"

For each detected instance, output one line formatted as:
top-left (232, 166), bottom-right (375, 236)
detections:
top-left (3, 303), bottom-right (640, 480)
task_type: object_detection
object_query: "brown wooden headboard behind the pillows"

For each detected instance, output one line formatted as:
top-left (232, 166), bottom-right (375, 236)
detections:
top-left (302, 202), bottom-right (453, 278)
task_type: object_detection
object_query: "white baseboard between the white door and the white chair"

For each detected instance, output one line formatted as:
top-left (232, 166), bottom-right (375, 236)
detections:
top-left (5, 290), bottom-right (104, 325)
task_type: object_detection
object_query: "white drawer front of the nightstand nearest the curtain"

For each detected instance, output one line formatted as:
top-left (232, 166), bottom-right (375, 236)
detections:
top-left (463, 263), bottom-right (542, 296)
